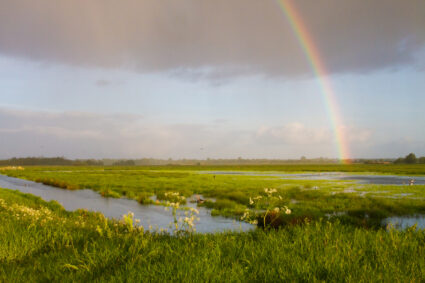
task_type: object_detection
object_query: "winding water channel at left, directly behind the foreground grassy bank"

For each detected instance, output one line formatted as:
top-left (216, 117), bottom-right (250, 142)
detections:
top-left (0, 175), bottom-right (255, 233)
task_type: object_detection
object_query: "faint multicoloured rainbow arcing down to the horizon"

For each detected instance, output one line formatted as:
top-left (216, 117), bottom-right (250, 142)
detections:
top-left (276, 0), bottom-right (350, 163)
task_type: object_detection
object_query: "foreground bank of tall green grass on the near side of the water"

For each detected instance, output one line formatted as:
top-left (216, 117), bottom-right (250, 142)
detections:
top-left (0, 189), bottom-right (425, 282)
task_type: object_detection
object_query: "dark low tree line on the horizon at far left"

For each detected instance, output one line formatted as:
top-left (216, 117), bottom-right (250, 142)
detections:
top-left (0, 157), bottom-right (103, 166)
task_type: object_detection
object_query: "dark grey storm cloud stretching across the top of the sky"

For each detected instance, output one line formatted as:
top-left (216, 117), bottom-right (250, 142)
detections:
top-left (0, 0), bottom-right (425, 76)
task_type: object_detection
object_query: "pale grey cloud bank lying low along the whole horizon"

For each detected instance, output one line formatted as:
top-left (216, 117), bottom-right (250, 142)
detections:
top-left (0, 108), bottom-right (425, 158)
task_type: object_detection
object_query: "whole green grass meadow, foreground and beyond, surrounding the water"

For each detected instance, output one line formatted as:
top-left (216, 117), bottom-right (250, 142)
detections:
top-left (0, 165), bottom-right (425, 282)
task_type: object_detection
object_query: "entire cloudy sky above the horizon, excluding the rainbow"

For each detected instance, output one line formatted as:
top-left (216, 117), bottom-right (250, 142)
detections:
top-left (0, 0), bottom-right (425, 159)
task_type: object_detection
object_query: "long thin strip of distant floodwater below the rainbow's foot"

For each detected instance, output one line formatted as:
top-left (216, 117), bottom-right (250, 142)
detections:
top-left (201, 171), bottom-right (425, 185)
